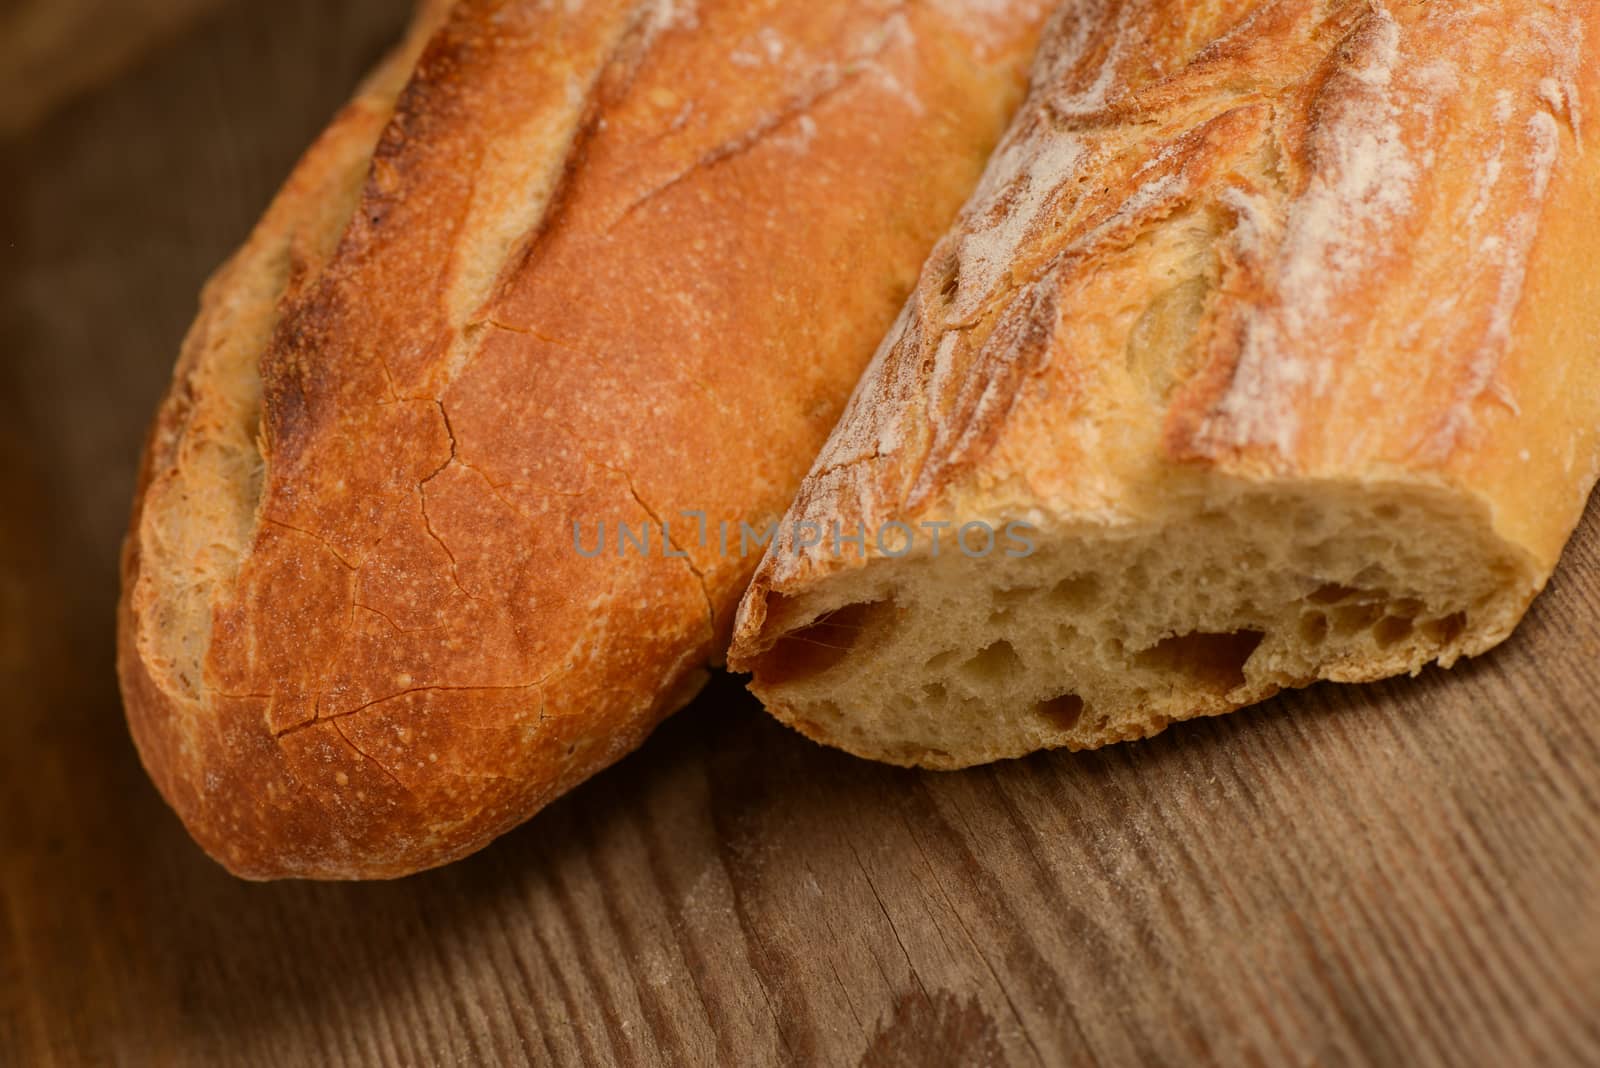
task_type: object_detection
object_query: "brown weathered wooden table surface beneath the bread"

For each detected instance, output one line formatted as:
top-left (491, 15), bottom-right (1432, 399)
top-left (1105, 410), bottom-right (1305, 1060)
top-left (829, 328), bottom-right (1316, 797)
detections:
top-left (0, 0), bottom-right (1600, 1066)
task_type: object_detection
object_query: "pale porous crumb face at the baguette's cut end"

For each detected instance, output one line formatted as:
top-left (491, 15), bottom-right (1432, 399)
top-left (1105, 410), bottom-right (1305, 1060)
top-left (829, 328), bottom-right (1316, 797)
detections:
top-left (734, 480), bottom-right (1538, 767)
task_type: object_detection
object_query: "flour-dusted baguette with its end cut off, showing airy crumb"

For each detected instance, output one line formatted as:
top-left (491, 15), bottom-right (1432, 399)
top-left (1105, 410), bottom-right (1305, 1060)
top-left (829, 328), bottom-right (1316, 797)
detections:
top-left (730, 0), bottom-right (1600, 767)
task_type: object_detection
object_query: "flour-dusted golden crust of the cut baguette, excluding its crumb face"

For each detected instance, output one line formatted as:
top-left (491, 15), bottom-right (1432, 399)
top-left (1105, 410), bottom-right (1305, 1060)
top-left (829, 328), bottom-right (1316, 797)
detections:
top-left (730, 0), bottom-right (1600, 764)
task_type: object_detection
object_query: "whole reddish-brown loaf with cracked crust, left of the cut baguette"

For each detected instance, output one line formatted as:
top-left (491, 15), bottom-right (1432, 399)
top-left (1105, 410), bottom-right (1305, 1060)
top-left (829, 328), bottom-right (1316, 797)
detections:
top-left (120, 0), bottom-right (1046, 878)
